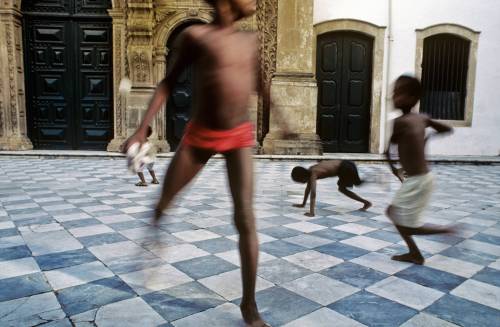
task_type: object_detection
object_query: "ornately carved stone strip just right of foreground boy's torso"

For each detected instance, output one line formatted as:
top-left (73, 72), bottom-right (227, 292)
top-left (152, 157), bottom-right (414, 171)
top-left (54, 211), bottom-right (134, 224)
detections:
top-left (257, 0), bottom-right (278, 141)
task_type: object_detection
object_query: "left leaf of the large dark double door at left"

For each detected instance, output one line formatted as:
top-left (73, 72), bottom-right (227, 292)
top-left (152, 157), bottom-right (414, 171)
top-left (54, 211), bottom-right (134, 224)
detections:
top-left (25, 19), bottom-right (73, 149)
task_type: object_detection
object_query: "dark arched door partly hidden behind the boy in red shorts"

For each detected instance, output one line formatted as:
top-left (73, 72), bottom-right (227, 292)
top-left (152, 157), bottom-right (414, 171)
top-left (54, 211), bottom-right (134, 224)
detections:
top-left (166, 24), bottom-right (195, 150)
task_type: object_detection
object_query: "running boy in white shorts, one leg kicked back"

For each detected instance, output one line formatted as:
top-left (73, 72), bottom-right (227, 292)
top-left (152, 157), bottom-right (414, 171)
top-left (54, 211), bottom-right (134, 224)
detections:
top-left (386, 75), bottom-right (452, 265)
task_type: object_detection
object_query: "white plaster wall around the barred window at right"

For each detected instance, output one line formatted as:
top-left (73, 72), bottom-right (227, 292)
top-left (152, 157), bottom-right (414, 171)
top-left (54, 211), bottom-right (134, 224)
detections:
top-left (314, 0), bottom-right (500, 155)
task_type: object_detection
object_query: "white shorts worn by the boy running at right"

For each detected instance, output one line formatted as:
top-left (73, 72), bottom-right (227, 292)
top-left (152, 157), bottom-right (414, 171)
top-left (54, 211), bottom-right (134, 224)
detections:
top-left (391, 173), bottom-right (434, 228)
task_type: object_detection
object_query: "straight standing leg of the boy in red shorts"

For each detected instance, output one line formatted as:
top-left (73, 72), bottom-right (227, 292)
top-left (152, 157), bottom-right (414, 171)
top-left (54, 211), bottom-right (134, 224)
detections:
top-left (225, 148), bottom-right (267, 326)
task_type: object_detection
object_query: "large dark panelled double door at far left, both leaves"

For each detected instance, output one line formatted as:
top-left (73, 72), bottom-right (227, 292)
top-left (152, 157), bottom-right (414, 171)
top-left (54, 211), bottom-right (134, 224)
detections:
top-left (23, 0), bottom-right (113, 150)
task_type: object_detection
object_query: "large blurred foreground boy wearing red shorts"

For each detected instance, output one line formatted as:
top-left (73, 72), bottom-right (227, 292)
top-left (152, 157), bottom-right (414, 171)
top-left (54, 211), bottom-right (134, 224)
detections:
top-left (124, 0), bottom-right (276, 326)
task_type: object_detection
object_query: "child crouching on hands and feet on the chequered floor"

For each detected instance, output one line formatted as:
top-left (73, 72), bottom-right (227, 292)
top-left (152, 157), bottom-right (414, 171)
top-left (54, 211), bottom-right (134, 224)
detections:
top-left (292, 160), bottom-right (372, 217)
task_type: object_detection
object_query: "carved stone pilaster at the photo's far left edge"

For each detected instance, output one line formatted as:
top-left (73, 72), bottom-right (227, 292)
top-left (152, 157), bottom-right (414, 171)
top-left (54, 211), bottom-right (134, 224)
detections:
top-left (0, 0), bottom-right (33, 150)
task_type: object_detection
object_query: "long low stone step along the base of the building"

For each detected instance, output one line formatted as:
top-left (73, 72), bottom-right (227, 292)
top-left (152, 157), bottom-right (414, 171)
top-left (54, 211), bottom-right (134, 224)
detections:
top-left (0, 150), bottom-right (500, 165)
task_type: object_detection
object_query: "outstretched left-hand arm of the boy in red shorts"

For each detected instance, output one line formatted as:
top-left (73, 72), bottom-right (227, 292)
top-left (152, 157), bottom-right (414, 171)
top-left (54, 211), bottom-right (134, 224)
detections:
top-left (122, 29), bottom-right (195, 152)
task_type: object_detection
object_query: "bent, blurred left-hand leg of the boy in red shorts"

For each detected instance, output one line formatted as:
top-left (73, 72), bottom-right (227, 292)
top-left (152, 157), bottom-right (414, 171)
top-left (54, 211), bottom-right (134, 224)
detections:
top-left (153, 146), bottom-right (212, 224)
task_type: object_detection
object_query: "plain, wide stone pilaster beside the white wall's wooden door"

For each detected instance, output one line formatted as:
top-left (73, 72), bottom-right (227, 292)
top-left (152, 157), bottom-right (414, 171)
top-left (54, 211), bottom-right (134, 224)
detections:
top-left (263, 0), bottom-right (322, 154)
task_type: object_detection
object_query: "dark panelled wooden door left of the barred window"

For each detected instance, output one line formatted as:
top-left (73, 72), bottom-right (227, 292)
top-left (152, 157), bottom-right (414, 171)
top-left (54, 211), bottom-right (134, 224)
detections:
top-left (316, 32), bottom-right (373, 153)
